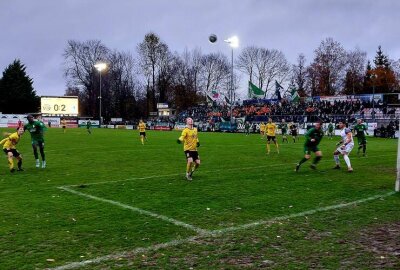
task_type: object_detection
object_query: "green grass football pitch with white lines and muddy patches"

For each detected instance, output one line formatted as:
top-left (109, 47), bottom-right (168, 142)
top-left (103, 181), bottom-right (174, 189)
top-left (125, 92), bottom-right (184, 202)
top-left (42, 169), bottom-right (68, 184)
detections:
top-left (0, 129), bottom-right (400, 269)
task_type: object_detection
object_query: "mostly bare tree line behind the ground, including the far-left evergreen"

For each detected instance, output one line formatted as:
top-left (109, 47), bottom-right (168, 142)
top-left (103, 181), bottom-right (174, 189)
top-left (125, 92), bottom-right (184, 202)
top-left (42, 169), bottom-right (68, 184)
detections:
top-left (0, 32), bottom-right (400, 120)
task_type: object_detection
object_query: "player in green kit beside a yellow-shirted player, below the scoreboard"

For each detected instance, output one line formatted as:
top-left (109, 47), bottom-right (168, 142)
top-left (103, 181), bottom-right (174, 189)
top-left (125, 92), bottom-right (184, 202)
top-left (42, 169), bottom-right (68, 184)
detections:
top-left (24, 115), bottom-right (46, 168)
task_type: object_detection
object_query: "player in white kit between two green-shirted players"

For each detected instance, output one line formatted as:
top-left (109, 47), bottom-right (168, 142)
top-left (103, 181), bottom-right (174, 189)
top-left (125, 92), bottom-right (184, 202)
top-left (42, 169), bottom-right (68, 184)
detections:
top-left (333, 122), bottom-right (354, 172)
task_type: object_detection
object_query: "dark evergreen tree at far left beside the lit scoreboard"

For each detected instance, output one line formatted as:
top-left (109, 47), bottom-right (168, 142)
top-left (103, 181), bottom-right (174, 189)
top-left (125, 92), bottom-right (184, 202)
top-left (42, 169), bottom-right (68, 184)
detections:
top-left (0, 59), bottom-right (40, 113)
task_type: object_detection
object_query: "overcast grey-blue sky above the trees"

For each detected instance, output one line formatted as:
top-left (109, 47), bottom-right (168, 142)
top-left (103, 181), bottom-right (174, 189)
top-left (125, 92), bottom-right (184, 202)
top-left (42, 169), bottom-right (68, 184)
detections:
top-left (0, 0), bottom-right (400, 95)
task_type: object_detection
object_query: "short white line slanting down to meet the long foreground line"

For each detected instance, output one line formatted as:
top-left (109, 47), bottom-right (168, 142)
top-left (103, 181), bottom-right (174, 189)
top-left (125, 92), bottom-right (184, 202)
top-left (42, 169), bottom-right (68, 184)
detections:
top-left (58, 187), bottom-right (209, 235)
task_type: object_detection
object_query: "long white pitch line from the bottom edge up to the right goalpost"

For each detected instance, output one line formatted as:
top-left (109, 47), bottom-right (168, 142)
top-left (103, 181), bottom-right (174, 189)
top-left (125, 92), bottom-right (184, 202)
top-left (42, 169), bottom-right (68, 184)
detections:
top-left (52, 191), bottom-right (396, 270)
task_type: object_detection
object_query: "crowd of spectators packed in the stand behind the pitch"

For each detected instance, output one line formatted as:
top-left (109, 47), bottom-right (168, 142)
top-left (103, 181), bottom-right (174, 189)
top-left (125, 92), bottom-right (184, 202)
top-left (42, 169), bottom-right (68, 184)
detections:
top-left (177, 100), bottom-right (400, 122)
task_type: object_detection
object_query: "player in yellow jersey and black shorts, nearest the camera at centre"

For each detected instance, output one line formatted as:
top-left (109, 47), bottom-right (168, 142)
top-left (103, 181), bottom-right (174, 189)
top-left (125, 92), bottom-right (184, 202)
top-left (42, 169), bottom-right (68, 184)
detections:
top-left (178, 118), bottom-right (200, 181)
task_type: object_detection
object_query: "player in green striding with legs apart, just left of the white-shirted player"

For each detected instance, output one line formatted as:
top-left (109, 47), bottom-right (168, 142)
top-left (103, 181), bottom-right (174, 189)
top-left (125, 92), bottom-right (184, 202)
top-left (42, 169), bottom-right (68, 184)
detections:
top-left (295, 122), bottom-right (324, 172)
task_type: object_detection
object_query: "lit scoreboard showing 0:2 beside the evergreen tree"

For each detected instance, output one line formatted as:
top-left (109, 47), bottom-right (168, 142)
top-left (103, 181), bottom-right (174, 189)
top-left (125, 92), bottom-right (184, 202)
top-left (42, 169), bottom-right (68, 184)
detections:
top-left (40, 96), bottom-right (78, 115)
